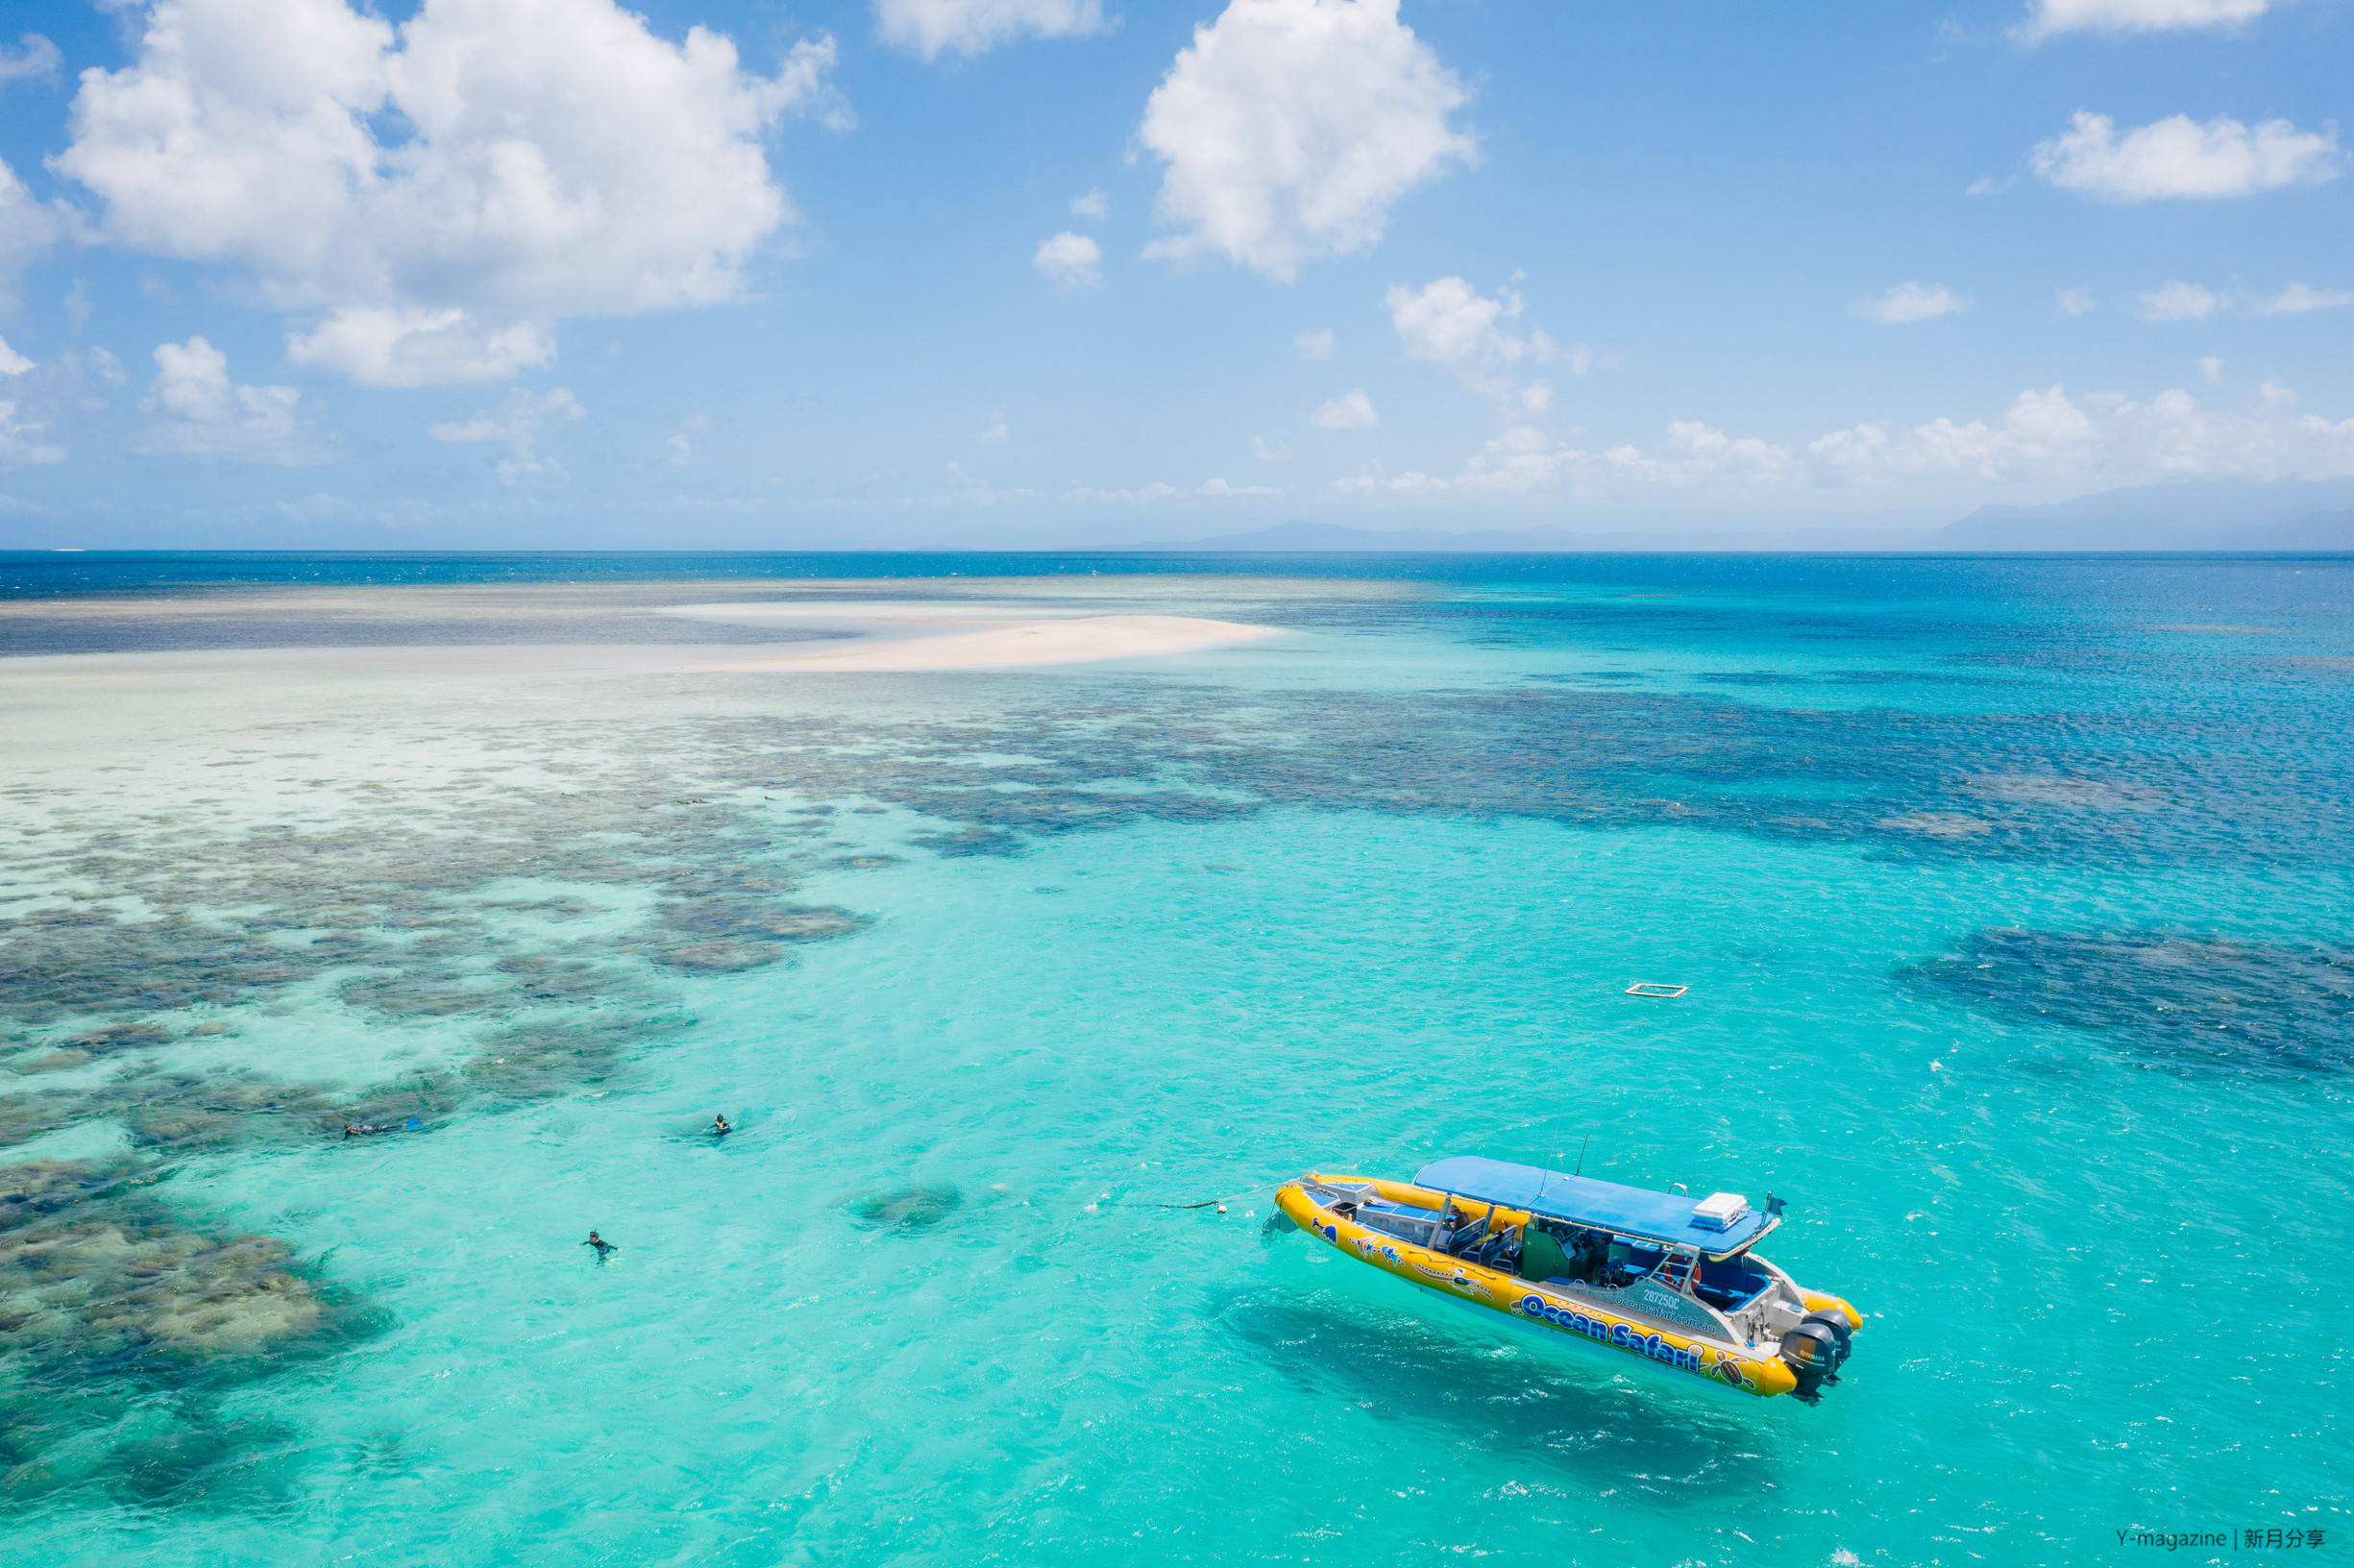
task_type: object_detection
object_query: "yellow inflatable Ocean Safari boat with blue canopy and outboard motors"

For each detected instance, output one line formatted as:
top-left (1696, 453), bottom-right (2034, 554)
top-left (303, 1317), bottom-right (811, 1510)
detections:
top-left (1276, 1154), bottom-right (1864, 1403)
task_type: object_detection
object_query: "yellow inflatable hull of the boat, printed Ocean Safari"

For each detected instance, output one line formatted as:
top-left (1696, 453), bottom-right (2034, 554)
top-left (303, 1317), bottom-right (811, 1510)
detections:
top-left (1276, 1177), bottom-right (1807, 1399)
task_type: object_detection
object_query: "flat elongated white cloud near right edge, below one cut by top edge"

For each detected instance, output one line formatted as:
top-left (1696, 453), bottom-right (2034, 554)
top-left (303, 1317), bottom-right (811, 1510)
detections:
top-left (2029, 110), bottom-right (2344, 203)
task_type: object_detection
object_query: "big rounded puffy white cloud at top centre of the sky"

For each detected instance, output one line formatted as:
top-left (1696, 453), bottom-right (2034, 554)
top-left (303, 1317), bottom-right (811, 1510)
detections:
top-left (1137, 0), bottom-right (1476, 282)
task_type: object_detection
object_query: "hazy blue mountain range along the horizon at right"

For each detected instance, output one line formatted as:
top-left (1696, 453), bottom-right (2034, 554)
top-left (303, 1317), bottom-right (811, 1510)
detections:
top-left (1118, 480), bottom-right (2354, 555)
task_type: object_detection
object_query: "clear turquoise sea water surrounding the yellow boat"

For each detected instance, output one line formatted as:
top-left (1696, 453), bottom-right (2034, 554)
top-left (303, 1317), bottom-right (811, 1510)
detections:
top-left (0, 558), bottom-right (2354, 1566)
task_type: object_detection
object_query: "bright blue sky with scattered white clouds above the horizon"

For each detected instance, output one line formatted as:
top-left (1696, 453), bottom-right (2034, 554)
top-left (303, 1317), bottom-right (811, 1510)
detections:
top-left (0, 0), bottom-right (2354, 549)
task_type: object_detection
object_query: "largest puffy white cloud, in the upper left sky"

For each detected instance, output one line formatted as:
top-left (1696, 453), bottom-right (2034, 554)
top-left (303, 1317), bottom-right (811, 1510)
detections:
top-left (57, 0), bottom-right (843, 386)
